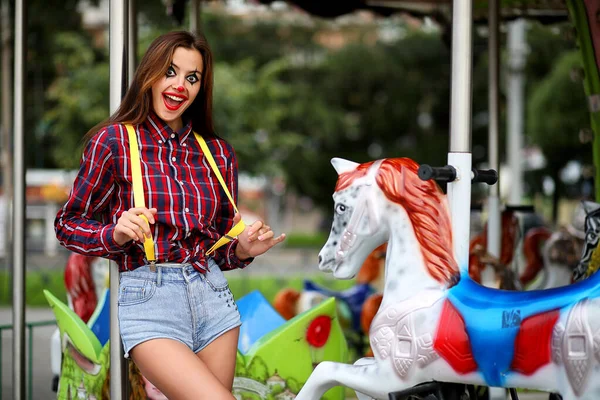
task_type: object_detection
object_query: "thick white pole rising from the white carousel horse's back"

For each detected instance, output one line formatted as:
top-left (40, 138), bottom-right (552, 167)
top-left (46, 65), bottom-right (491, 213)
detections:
top-left (448, 0), bottom-right (473, 270)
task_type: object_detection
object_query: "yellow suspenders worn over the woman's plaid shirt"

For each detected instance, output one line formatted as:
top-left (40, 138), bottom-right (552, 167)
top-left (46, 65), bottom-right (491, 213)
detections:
top-left (125, 124), bottom-right (246, 264)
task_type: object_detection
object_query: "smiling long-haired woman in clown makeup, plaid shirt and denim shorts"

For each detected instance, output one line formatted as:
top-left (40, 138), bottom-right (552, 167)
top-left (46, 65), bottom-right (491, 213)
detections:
top-left (55, 32), bottom-right (285, 400)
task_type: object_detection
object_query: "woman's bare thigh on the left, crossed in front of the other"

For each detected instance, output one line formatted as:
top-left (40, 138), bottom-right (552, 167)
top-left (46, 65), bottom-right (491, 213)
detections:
top-left (131, 339), bottom-right (235, 400)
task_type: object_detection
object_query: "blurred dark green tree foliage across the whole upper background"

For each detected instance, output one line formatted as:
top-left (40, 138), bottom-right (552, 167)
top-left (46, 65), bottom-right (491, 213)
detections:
top-left (31, 7), bottom-right (591, 212)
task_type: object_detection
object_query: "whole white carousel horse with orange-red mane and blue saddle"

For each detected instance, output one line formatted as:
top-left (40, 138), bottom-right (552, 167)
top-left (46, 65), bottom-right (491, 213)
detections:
top-left (296, 158), bottom-right (600, 400)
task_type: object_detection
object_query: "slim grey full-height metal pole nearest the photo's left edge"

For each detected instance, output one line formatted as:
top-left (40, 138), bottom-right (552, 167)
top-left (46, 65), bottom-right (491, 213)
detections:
top-left (12, 0), bottom-right (27, 400)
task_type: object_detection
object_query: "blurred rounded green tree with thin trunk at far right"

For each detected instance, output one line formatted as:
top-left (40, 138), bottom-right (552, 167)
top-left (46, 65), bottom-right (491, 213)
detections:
top-left (527, 51), bottom-right (592, 220)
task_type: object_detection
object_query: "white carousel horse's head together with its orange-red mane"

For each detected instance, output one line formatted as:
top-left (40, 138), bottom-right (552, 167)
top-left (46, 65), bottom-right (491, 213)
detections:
top-left (319, 158), bottom-right (458, 282)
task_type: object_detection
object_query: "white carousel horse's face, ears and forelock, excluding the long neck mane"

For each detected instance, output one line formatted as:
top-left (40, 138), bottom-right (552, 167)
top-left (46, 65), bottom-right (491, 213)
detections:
top-left (319, 158), bottom-right (387, 279)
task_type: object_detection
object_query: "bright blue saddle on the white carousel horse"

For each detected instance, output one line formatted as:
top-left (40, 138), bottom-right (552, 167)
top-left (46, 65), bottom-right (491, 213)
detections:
top-left (448, 273), bottom-right (600, 386)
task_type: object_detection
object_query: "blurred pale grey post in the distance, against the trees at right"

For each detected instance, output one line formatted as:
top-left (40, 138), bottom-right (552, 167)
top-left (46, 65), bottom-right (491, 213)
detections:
top-left (507, 19), bottom-right (527, 204)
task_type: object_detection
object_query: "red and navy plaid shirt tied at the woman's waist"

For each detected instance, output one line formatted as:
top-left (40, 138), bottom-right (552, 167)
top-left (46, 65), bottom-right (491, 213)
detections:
top-left (54, 113), bottom-right (251, 272)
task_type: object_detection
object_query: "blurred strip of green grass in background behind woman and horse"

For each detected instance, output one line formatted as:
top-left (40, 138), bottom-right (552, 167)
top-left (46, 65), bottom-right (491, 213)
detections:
top-left (0, 269), bottom-right (354, 307)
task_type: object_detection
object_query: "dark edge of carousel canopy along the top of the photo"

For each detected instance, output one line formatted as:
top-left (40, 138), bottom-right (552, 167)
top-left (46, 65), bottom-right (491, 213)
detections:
top-left (259, 0), bottom-right (568, 23)
